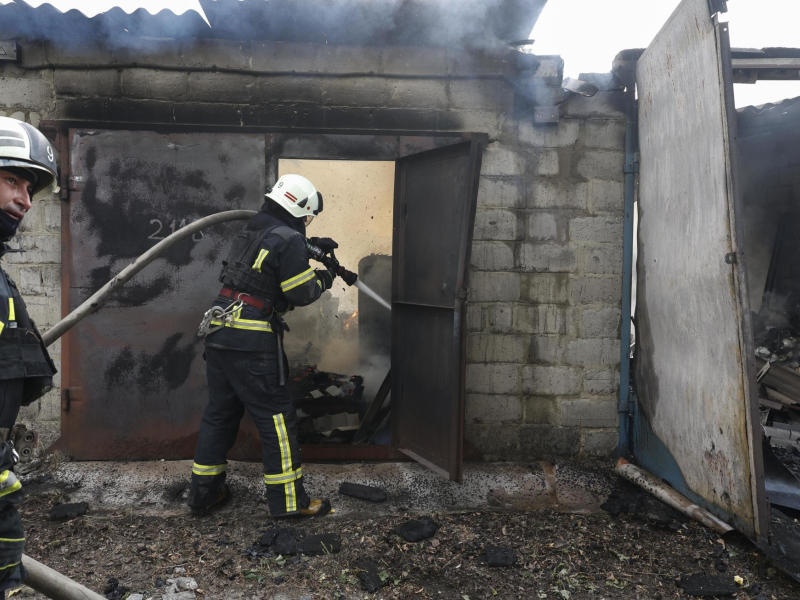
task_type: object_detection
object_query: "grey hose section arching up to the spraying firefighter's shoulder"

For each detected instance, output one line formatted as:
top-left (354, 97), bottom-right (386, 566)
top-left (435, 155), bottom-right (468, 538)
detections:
top-left (42, 210), bottom-right (256, 346)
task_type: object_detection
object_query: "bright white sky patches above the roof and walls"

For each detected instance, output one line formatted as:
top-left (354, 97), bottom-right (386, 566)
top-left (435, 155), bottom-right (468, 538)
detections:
top-left (6, 0), bottom-right (800, 106)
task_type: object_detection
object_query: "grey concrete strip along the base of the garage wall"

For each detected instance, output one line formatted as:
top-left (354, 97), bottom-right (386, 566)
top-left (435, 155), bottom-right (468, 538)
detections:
top-left (34, 461), bottom-right (614, 517)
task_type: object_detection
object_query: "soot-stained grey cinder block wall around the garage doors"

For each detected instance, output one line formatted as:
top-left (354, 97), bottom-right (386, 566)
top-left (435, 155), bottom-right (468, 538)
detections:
top-left (0, 40), bottom-right (624, 460)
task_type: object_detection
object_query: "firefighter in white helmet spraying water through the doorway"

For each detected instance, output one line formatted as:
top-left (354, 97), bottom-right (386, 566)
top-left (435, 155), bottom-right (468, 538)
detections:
top-left (189, 175), bottom-right (338, 517)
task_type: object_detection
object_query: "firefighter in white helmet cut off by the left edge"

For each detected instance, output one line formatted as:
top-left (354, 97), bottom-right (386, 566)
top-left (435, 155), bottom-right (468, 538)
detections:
top-left (0, 117), bottom-right (58, 593)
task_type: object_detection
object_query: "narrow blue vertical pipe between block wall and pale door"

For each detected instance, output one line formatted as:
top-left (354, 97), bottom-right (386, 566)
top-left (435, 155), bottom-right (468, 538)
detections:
top-left (617, 69), bottom-right (639, 457)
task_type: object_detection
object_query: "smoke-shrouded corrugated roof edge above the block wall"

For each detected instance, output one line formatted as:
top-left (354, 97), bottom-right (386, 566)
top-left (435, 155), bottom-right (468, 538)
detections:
top-left (0, 0), bottom-right (547, 48)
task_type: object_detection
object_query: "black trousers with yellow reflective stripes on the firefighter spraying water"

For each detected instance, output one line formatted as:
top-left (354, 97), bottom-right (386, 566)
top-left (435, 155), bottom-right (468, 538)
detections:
top-left (189, 347), bottom-right (310, 517)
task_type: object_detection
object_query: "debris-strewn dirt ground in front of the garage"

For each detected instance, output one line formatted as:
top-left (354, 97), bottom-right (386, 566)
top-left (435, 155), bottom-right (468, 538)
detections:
top-left (9, 472), bottom-right (800, 600)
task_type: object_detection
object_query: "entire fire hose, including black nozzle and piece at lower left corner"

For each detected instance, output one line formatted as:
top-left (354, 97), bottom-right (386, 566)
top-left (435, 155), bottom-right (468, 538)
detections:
top-left (28, 210), bottom-right (388, 600)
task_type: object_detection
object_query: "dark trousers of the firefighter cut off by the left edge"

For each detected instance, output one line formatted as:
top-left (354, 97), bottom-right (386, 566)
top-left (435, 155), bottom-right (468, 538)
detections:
top-left (0, 379), bottom-right (27, 597)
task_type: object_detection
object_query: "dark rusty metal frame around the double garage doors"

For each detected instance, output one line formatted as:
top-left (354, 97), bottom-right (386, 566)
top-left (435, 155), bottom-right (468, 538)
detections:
top-left (47, 121), bottom-right (488, 460)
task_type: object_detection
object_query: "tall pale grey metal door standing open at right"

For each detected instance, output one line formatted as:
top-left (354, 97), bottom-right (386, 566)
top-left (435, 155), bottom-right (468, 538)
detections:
top-left (634, 0), bottom-right (768, 536)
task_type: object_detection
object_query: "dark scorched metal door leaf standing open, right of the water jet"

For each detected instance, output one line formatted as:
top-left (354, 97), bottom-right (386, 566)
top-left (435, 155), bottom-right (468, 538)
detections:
top-left (392, 141), bottom-right (481, 482)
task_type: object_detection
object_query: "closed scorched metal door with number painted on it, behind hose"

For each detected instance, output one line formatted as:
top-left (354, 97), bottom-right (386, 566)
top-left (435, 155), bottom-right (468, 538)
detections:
top-left (59, 130), bottom-right (265, 460)
